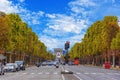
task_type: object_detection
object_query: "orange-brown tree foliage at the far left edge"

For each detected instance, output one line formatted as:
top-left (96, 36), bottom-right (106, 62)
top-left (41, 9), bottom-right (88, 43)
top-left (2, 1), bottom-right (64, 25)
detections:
top-left (0, 12), bottom-right (10, 49)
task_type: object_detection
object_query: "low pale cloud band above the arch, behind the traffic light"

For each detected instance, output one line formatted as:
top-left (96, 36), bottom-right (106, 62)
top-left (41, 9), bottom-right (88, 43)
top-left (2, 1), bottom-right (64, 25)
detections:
top-left (40, 34), bottom-right (84, 50)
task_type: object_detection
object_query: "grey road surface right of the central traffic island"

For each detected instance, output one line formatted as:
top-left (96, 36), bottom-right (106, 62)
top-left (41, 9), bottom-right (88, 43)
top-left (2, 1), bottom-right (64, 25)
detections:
top-left (65, 65), bottom-right (120, 80)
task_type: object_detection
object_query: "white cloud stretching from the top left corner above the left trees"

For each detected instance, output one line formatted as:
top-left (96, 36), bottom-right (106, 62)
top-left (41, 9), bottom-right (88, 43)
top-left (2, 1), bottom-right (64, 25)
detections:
top-left (0, 0), bottom-right (44, 25)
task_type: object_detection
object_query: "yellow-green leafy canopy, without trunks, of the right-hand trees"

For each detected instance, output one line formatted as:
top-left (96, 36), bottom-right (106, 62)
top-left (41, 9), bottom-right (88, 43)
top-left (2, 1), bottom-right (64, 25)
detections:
top-left (70, 16), bottom-right (120, 58)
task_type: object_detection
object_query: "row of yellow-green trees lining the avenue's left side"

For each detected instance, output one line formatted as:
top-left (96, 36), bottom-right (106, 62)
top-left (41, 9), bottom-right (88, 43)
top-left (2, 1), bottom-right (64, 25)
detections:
top-left (0, 12), bottom-right (53, 63)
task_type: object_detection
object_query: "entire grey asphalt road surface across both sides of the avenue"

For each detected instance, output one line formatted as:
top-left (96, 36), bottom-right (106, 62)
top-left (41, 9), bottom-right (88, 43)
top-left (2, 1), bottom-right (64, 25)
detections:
top-left (0, 65), bottom-right (120, 80)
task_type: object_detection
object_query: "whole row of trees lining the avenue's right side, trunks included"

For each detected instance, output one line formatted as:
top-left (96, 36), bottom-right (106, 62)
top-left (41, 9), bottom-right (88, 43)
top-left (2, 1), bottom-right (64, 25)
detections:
top-left (69, 16), bottom-right (120, 64)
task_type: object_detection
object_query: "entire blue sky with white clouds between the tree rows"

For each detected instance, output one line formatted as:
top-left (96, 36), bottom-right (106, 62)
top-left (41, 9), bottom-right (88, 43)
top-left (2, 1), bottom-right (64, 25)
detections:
top-left (0, 0), bottom-right (120, 50)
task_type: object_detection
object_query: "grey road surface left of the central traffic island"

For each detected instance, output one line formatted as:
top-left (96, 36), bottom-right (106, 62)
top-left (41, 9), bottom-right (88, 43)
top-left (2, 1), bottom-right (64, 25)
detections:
top-left (0, 66), bottom-right (63, 80)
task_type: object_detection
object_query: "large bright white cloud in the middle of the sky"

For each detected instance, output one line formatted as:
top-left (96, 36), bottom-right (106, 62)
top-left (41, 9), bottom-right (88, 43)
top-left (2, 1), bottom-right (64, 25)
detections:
top-left (47, 14), bottom-right (88, 34)
